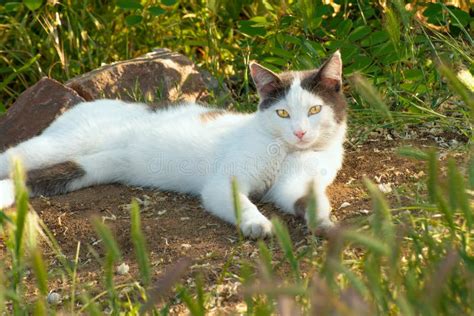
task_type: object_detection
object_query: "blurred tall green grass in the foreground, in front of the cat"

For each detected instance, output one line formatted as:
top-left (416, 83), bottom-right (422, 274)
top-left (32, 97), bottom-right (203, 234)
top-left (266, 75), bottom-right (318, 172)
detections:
top-left (0, 139), bottom-right (474, 315)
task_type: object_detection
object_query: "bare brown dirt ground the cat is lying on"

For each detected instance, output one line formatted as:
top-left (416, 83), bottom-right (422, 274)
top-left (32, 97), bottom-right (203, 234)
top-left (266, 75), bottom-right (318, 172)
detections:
top-left (0, 132), bottom-right (466, 312)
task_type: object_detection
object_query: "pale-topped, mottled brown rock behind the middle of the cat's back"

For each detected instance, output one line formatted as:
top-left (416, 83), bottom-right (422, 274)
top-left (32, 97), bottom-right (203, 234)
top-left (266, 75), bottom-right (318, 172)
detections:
top-left (66, 49), bottom-right (208, 104)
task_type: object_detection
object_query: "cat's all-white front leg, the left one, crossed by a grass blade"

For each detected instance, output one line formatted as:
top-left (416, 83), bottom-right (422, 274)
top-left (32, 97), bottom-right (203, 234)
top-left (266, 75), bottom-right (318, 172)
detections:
top-left (201, 181), bottom-right (272, 238)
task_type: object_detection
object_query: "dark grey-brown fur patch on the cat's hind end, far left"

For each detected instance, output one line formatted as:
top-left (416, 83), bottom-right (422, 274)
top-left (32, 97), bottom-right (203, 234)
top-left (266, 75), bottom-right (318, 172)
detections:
top-left (26, 161), bottom-right (86, 196)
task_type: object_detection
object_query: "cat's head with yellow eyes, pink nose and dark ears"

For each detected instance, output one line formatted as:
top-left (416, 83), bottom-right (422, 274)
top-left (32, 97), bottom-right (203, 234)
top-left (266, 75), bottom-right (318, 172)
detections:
top-left (250, 51), bottom-right (347, 150)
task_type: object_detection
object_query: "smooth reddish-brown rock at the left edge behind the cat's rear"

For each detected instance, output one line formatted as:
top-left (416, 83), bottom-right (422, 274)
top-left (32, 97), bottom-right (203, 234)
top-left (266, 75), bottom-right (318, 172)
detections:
top-left (0, 77), bottom-right (84, 152)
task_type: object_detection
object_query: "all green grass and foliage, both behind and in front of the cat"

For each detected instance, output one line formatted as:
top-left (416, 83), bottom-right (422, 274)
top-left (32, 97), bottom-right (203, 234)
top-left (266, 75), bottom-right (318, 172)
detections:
top-left (0, 0), bottom-right (474, 315)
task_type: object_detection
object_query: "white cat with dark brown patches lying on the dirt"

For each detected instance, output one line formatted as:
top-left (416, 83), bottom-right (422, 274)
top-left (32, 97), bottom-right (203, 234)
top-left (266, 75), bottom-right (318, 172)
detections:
top-left (0, 51), bottom-right (347, 238)
